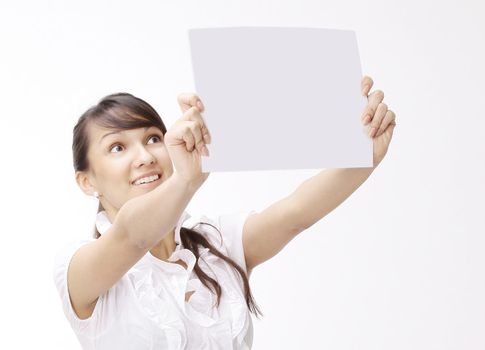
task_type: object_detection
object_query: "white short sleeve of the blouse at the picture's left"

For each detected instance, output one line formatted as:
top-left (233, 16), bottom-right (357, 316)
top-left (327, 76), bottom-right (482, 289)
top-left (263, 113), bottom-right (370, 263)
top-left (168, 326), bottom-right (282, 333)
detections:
top-left (53, 238), bottom-right (101, 333)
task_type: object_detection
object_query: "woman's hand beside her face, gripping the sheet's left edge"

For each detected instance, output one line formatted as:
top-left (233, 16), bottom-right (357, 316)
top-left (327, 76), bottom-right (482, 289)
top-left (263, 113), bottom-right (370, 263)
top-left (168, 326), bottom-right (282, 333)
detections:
top-left (164, 93), bottom-right (211, 186)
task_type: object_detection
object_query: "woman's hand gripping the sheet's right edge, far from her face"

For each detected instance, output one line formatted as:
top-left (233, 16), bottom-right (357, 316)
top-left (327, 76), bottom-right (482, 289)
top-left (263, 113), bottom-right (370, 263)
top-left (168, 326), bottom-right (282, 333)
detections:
top-left (361, 76), bottom-right (396, 167)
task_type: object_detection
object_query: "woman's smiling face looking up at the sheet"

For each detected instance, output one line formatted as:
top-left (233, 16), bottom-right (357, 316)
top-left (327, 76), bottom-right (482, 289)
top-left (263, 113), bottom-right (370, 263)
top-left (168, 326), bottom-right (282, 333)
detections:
top-left (82, 123), bottom-right (173, 214)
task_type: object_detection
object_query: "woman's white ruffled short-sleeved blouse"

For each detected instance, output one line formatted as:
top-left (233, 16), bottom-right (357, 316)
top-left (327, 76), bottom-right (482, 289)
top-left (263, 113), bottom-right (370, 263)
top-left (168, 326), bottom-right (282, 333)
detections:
top-left (54, 211), bottom-right (254, 350)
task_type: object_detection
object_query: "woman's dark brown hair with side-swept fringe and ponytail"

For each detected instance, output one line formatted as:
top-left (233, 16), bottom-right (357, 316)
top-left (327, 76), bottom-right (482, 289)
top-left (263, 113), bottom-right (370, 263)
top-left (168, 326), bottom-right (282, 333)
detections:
top-left (72, 93), bottom-right (262, 317)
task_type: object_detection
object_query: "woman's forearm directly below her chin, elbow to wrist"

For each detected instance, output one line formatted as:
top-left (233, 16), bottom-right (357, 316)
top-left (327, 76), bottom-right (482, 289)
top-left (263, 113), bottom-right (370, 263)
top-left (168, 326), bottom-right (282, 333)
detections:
top-left (117, 173), bottom-right (200, 250)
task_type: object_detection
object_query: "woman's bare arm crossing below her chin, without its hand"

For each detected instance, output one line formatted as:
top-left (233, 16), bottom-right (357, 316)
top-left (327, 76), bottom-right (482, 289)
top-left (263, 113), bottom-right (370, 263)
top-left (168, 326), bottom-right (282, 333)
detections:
top-left (67, 174), bottom-right (195, 319)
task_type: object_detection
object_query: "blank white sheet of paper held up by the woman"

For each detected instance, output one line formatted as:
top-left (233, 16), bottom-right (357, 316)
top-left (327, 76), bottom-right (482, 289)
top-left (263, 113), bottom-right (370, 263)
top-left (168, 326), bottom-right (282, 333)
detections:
top-left (188, 27), bottom-right (372, 172)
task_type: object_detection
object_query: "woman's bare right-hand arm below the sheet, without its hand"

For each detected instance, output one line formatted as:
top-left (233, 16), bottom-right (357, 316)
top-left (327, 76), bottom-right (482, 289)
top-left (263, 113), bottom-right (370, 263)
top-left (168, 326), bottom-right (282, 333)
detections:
top-left (243, 168), bottom-right (374, 271)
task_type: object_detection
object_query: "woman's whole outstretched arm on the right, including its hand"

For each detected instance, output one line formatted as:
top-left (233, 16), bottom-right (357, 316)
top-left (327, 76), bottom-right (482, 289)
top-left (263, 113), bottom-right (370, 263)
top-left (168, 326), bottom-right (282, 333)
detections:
top-left (243, 77), bottom-right (396, 271)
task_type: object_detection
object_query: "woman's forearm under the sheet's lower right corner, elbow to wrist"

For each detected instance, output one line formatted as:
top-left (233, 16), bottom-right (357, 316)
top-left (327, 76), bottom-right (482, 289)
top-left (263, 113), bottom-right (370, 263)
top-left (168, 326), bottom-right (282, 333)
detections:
top-left (290, 168), bottom-right (375, 230)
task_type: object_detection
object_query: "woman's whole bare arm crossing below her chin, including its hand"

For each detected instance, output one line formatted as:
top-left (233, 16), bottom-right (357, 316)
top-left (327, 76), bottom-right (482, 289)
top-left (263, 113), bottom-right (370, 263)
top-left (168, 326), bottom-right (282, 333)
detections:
top-left (67, 95), bottom-right (209, 319)
